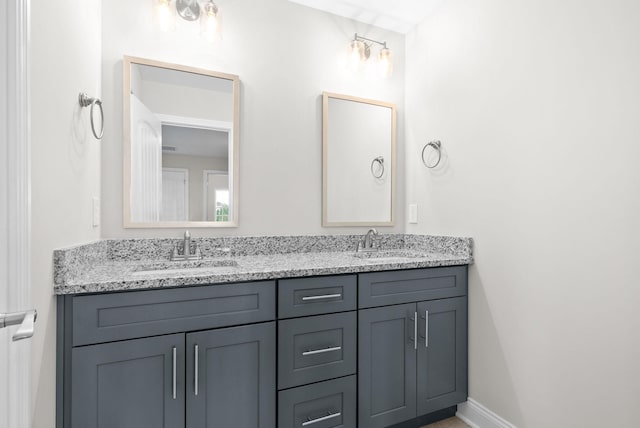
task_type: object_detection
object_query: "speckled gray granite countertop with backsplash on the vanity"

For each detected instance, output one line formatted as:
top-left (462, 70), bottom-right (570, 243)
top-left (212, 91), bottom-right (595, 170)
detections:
top-left (54, 234), bottom-right (473, 295)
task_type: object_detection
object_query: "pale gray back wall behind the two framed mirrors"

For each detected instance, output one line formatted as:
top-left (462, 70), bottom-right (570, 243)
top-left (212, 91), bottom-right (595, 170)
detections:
top-left (102, 0), bottom-right (404, 238)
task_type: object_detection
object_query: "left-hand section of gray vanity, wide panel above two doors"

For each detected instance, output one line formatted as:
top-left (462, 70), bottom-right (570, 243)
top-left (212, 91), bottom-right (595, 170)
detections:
top-left (57, 281), bottom-right (276, 428)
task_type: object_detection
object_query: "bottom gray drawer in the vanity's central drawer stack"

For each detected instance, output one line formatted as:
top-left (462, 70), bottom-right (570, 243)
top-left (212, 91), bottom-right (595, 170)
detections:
top-left (278, 376), bottom-right (356, 428)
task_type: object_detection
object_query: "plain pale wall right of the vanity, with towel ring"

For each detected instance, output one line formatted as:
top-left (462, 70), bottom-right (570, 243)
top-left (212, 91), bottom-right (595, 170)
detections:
top-left (405, 0), bottom-right (640, 428)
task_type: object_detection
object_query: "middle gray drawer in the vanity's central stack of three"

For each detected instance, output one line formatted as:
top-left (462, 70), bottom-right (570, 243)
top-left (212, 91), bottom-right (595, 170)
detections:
top-left (278, 311), bottom-right (357, 389)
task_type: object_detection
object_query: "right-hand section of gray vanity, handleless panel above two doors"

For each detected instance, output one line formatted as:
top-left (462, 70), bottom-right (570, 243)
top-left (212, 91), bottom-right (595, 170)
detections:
top-left (358, 266), bottom-right (467, 428)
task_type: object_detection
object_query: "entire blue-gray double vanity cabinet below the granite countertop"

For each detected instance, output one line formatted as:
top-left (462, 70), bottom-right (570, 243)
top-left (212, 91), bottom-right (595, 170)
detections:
top-left (56, 266), bottom-right (467, 428)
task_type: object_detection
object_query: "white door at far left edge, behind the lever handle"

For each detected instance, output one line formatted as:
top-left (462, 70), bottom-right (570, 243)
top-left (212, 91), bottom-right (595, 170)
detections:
top-left (0, 0), bottom-right (32, 428)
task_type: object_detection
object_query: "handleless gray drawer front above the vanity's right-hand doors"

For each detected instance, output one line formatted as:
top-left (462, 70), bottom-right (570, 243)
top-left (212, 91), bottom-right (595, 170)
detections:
top-left (358, 266), bottom-right (467, 308)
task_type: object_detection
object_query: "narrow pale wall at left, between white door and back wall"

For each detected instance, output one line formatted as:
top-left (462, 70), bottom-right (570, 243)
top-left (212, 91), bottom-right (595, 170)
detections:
top-left (30, 0), bottom-right (104, 428)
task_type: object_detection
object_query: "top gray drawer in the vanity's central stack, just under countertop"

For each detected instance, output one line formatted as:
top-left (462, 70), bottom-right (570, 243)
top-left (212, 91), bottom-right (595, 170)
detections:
top-left (278, 275), bottom-right (357, 318)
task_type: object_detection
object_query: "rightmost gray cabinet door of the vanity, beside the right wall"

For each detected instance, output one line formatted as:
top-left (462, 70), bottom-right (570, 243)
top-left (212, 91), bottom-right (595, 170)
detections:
top-left (418, 297), bottom-right (467, 415)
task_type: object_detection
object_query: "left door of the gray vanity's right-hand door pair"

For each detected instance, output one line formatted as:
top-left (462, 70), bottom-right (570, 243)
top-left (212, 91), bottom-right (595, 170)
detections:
top-left (358, 303), bottom-right (416, 428)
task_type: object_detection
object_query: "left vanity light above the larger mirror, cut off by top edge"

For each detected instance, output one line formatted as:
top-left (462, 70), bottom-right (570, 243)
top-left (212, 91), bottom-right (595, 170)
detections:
top-left (153, 0), bottom-right (219, 42)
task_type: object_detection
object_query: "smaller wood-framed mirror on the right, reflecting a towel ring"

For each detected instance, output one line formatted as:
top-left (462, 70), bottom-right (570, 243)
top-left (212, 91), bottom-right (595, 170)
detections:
top-left (322, 92), bottom-right (396, 226)
